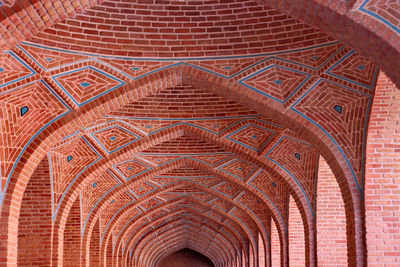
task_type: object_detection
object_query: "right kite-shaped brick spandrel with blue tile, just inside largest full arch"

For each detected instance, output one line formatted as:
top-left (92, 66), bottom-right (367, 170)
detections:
top-left (267, 137), bottom-right (318, 211)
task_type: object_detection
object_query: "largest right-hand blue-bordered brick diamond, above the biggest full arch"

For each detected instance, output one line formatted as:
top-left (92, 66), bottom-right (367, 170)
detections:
top-left (241, 65), bottom-right (311, 103)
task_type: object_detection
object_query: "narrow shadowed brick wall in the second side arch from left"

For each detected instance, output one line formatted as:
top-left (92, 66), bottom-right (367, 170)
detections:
top-left (63, 197), bottom-right (81, 266)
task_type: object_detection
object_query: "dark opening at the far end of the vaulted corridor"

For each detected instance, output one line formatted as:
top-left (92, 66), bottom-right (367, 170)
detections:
top-left (158, 248), bottom-right (214, 267)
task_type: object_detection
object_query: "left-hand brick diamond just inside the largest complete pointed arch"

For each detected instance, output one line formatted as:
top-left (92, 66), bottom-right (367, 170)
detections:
top-left (92, 125), bottom-right (140, 153)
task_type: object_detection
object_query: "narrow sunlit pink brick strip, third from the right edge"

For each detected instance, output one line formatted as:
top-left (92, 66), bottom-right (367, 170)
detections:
top-left (288, 196), bottom-right (306, 267)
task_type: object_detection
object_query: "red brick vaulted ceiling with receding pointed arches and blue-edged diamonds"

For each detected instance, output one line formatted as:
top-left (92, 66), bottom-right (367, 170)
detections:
top-left (0, 0), bottom-right (386, 266)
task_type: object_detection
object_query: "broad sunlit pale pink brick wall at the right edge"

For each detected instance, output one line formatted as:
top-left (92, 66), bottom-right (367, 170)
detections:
top-left (365, 72), bottom-right (400, 266)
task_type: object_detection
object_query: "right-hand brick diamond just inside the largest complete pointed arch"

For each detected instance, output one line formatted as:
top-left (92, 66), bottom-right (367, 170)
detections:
top-left (226, 124), bottom-right (275, 152)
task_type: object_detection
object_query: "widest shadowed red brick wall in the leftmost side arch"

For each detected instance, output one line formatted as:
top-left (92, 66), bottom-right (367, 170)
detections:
top-left (18, 157), bottom-right (52, 266)
